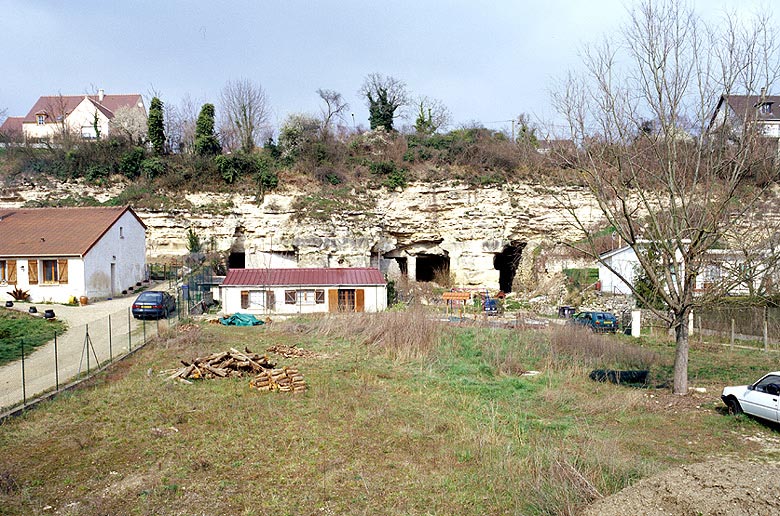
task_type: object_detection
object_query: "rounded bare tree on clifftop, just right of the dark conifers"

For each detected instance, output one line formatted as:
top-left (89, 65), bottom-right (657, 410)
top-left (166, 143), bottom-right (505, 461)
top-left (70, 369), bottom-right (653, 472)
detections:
top-left (220, 79), bottom-right (270, 152)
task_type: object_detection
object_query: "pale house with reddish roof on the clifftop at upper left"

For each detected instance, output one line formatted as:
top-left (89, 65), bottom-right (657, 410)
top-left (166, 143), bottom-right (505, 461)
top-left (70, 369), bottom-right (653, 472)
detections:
top-left (0, 90), bottom-right (146, 140)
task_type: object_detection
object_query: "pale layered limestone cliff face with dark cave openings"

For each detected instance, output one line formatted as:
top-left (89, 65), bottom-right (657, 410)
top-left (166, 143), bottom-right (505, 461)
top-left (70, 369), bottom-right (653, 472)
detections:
top-left (0, 178), bottom-right (600, 290)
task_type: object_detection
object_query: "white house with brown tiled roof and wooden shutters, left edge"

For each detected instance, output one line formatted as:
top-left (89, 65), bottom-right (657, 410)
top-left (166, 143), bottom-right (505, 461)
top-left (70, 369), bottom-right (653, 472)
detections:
top-left (0, 207), bottom-right (146, 303)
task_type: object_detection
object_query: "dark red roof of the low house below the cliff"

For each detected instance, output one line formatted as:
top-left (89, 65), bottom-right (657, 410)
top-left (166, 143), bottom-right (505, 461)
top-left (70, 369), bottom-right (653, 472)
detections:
top-left (222, 267), bottom-right (385, 287)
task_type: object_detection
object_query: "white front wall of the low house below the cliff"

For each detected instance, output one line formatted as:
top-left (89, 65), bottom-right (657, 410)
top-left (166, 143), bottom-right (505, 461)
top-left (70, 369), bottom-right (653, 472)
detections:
top-left (220, 285), bottom-right (387, 315)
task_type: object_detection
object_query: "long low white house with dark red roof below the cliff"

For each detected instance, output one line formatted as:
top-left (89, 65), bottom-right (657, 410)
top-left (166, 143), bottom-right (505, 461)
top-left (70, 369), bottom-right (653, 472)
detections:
top-left (220, 268), bottom-right (387, 315)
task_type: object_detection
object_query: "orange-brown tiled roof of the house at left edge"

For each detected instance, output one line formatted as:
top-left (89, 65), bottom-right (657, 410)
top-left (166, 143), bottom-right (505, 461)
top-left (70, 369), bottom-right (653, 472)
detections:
top-left (0, 206), bottom-right (146, 257)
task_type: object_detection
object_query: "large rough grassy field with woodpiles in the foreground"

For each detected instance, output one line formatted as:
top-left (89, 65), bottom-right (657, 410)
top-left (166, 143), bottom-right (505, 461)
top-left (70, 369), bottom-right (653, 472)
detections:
top-left (0, 312), bottom-right (780, 515)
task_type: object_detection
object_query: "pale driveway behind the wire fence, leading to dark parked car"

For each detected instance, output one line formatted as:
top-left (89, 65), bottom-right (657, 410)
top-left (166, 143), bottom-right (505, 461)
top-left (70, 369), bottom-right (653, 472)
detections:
top-left (0, 294), bottom-right (174, 412)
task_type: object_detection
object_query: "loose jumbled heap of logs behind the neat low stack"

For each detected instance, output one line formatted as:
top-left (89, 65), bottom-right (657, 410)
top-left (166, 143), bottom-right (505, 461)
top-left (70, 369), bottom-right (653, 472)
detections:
top-left (166, 348), bottom-right (276, 380)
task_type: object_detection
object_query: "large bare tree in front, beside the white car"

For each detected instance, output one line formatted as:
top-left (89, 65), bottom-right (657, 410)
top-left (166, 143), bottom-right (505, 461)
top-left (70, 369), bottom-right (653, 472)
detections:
top-left (553, 0), bottom-right (780, 394)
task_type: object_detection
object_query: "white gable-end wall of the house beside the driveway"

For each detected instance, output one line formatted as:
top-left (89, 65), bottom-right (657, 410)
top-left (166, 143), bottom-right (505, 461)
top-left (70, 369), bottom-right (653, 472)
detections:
top-left (84, 212), bottom-right (146, 299)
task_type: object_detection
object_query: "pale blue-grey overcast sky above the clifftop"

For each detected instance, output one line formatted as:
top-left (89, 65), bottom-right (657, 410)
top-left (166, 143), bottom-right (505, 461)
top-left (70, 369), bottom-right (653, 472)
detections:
top-left (0, 0), bottom-right (776, 136)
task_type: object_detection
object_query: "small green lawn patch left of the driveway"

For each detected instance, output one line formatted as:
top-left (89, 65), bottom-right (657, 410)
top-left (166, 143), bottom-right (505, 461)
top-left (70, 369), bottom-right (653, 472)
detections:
top-left (0, 308), bottom-right (65, 365)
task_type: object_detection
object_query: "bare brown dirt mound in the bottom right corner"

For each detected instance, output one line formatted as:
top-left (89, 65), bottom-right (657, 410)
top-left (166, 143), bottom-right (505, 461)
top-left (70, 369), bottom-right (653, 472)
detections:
top-left (583, 458), bottom-right (780, 516)
